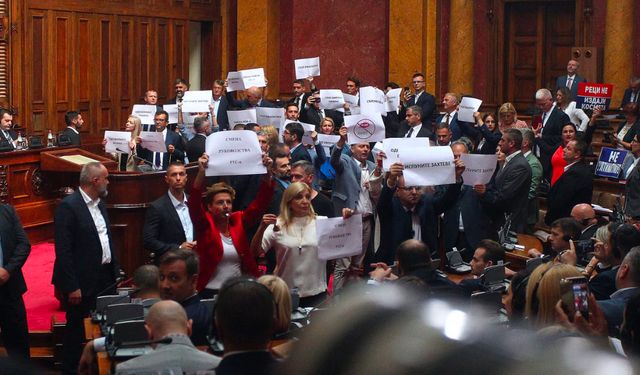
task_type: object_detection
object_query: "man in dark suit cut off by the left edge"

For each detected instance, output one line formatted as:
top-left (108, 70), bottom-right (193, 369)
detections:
top-left (0, 204), bottom-right (31, 360)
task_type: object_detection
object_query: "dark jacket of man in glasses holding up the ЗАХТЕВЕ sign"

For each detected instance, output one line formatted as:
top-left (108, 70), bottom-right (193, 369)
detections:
top-left (374, 182), bottom-right (462, 264)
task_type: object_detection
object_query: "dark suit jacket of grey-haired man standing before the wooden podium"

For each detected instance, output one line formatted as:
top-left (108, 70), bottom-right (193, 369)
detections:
top-left (52, 189), bottom-right (120, 297)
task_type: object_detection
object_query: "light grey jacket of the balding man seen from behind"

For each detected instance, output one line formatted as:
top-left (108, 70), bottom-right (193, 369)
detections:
top-left (116, 335), bottom-right (220, 374)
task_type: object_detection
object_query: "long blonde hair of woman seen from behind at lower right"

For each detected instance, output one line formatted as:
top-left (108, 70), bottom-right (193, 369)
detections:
top-left (525, 263), bottom-right (582, 328)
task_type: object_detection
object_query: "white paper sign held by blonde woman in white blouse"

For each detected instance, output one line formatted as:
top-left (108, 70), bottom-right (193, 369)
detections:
top-left (316, 214), bottom-right (362, 260)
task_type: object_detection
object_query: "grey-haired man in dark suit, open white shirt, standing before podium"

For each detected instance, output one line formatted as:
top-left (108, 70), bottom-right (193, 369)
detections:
top-left (52, 162), bottom-right (120, 373)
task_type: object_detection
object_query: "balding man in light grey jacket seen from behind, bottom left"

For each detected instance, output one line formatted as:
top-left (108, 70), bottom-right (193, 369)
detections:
top-left (116, 300), bottom-right (220, 374)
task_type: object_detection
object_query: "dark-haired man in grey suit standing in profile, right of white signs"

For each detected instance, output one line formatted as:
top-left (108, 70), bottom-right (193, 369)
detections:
top-left (473, 129), bottom-right (531, 233)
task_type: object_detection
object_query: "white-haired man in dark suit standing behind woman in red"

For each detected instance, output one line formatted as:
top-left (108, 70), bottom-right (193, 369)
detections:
top-left (533, 89), bottom-right (571, 179)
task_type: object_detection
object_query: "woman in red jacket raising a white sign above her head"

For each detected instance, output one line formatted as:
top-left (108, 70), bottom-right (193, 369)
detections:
top-left (187, 154), bottom-right (274, 298)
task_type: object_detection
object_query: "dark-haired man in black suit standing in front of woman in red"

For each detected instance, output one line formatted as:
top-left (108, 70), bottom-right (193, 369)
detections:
top-left (544, 140), bottom-right (593, 225)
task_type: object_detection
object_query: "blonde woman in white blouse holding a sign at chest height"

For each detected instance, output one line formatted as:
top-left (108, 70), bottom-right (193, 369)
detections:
top-left (251, 182), bottom-right (327, 307)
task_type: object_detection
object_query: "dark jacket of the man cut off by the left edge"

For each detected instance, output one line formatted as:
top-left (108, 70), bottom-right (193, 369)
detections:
top-left (0, 204), bottom-right (31, 298)
